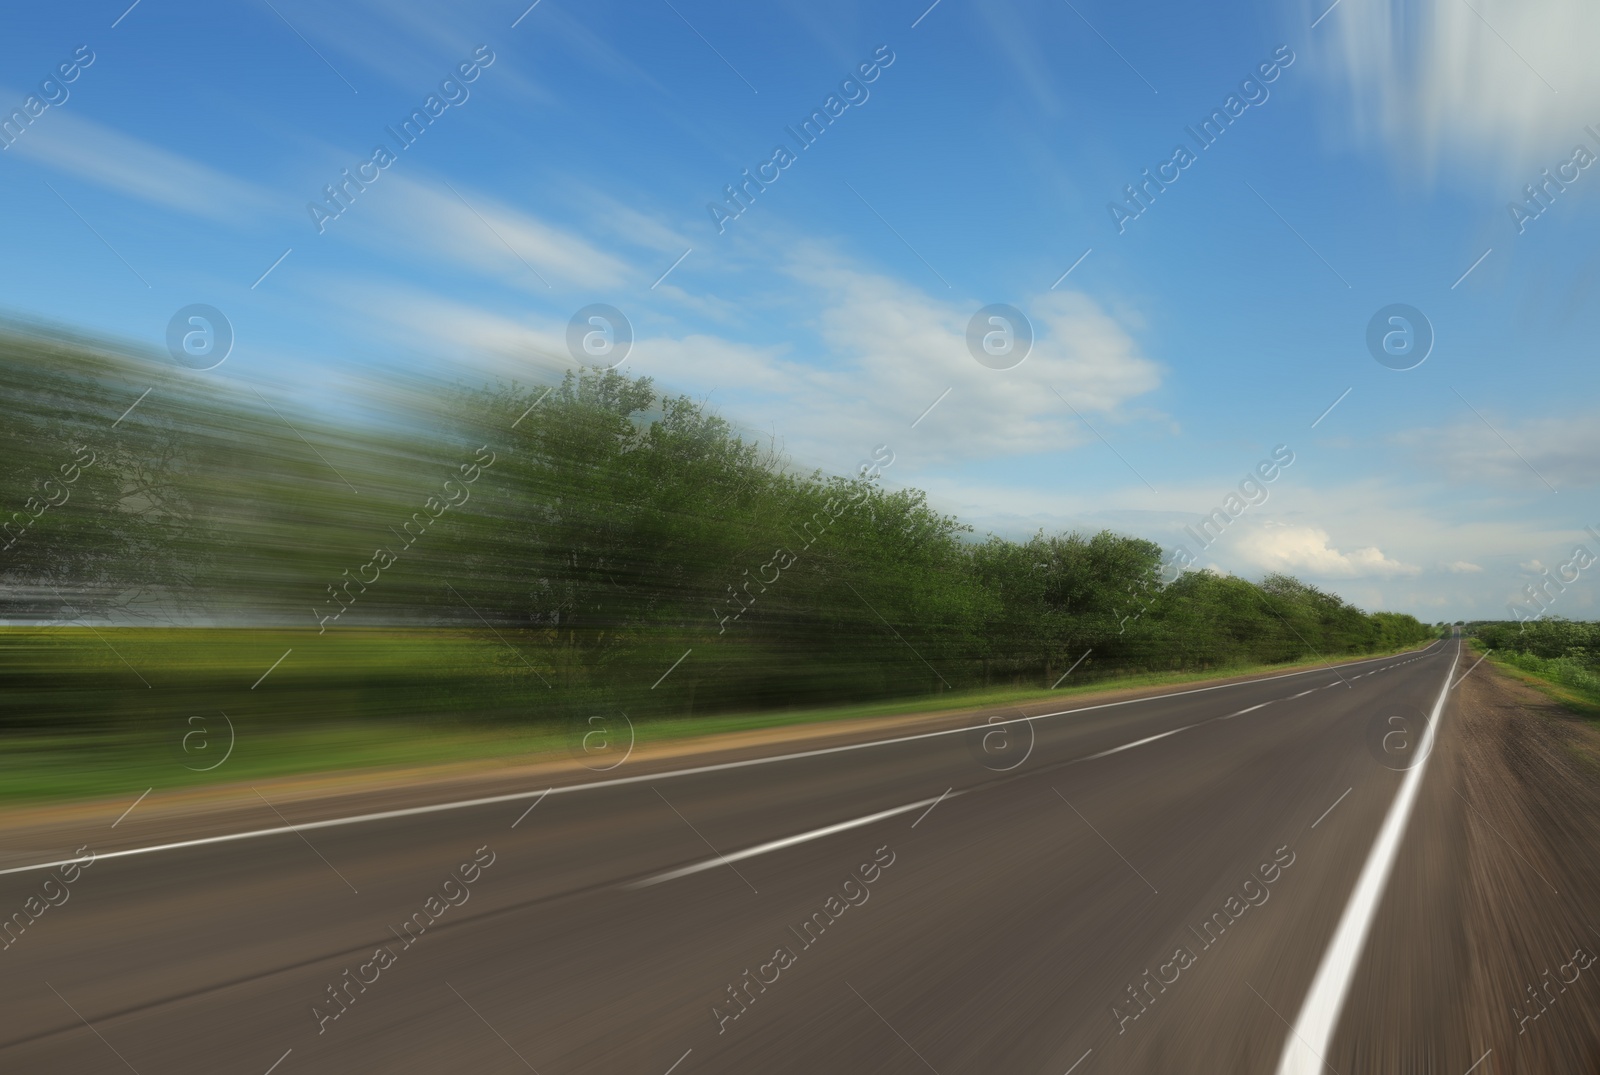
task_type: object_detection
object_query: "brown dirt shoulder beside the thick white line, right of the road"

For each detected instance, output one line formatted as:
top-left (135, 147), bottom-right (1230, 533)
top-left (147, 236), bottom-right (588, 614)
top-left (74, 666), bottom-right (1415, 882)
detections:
top-left (1429, 661), bottom-right (1600, 1072)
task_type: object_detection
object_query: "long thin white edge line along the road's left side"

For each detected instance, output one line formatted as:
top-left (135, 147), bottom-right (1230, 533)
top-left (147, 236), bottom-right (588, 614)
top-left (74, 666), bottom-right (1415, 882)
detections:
top-left (0, 641), bottom-right (1438, 877)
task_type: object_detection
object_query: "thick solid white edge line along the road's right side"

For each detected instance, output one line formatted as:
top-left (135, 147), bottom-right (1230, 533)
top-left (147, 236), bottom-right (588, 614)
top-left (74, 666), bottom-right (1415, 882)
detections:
top-left (1278, 637), bottom-right (1461, 1075)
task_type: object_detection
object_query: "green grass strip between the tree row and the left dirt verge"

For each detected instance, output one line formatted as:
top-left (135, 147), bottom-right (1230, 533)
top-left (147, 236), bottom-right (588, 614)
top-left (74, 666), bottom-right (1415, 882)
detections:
top-left (0, 629), bottom-right (1433, 803)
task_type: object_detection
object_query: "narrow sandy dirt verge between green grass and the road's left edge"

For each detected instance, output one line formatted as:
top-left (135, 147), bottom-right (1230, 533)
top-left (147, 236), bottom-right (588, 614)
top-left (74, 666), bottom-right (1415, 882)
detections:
top-left (0, 646), bottom-right (1440, 869)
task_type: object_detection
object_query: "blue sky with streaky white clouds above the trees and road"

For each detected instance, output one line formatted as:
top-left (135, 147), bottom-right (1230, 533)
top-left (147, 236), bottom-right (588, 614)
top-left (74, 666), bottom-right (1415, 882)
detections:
top-left (0, 0), bottom-right (1600, 621)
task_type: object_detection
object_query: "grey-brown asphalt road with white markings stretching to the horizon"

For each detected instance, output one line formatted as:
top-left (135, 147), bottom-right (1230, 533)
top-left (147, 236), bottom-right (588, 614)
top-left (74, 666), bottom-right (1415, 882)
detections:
top-left (0, 640), bottom-right (1516, 1075)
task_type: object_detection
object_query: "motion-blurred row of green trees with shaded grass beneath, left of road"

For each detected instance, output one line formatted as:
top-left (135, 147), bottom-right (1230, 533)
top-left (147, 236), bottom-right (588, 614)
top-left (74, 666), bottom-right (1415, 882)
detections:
top-left (0, 330), bottom-right (1435, 751)
